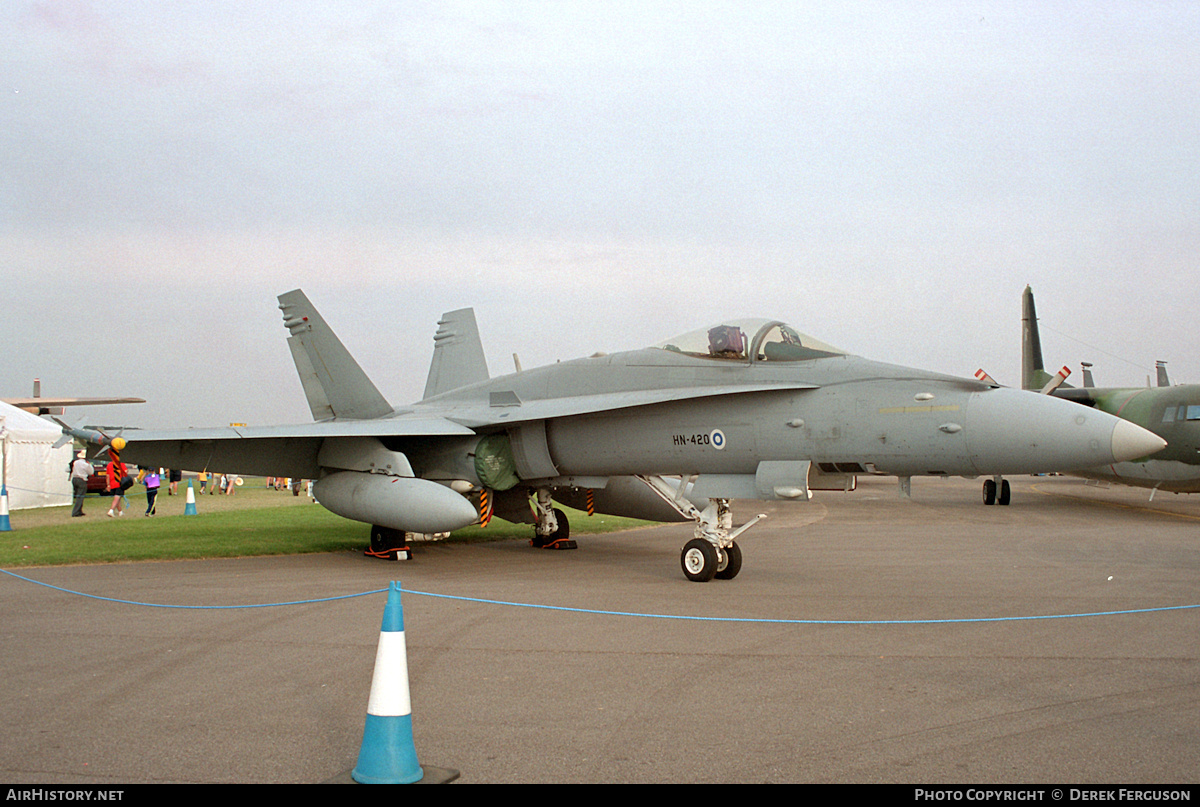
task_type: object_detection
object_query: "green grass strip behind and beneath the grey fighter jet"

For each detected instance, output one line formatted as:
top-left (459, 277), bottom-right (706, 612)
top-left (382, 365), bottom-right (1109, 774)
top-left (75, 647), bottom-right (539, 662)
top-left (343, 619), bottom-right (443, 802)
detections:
top-left (0, 477), bottom-right (647, 568)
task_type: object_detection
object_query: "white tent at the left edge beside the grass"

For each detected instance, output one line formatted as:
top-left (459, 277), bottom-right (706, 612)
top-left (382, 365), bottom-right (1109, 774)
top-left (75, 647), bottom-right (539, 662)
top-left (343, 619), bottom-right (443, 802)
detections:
top-left (0, 401), bottom-right (72, 510)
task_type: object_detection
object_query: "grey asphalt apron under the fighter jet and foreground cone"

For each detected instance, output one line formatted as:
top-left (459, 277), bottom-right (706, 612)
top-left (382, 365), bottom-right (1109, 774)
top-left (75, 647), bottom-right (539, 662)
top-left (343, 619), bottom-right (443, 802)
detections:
top-left (0, 478), bottom-right (1200, 785)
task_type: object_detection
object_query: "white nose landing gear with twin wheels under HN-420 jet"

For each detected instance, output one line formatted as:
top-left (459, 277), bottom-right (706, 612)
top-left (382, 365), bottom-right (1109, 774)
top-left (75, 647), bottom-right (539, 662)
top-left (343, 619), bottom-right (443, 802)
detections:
top-left (638, 477), bottom-right (767, 582)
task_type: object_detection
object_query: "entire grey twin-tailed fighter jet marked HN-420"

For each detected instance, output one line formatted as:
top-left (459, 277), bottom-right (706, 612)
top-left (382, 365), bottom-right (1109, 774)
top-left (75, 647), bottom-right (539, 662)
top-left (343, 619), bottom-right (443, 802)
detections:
top-left (58, 289), bottom-right (1163, 581)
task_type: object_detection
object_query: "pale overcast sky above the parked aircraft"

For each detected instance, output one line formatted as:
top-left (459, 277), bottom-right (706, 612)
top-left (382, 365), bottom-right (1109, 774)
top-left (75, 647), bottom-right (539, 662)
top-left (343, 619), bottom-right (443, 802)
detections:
top-left (0, 0), bottom-right (1200, 426)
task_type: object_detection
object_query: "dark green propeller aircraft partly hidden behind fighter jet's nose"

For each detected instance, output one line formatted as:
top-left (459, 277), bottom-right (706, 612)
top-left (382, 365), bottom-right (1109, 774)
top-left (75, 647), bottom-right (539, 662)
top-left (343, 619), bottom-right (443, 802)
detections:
top-left (1021, 286), bottom-right (1200, 498)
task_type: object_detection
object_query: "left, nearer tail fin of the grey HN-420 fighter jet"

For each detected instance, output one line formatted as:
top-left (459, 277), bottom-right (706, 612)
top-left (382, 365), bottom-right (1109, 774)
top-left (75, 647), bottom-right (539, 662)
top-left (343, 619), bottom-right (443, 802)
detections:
top-left (278, 288), bottom-right (392, 420)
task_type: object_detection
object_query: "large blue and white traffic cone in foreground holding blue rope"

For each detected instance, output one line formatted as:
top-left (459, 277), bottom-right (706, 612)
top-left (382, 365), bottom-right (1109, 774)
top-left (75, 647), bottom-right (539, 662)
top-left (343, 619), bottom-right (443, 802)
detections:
top-left (350, 582), bottom-right (424, 784)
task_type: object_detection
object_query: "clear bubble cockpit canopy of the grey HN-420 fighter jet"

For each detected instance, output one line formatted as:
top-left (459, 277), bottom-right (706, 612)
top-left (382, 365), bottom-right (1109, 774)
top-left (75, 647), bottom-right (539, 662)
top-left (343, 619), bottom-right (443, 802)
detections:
top-left (654, 319), bottom-right (846, 361)
